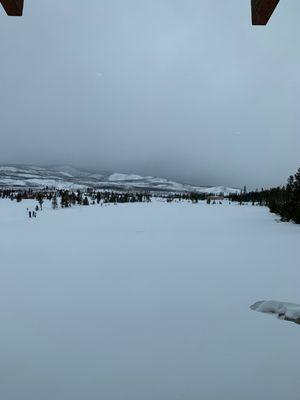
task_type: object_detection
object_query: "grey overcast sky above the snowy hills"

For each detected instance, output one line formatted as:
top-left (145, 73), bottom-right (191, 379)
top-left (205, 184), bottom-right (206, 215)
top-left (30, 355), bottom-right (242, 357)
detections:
top-left (0, 0), bottom-right (300, 187)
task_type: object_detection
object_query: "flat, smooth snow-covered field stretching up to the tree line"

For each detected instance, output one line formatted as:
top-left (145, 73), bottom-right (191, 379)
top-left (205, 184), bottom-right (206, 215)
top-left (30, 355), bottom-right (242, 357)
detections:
top-left (0, 200), bottom-right (300, 400)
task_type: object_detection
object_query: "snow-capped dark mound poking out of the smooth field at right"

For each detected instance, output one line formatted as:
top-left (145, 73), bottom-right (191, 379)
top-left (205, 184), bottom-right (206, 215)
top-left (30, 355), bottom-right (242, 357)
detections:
top-left (250, 300), bottom-right (300, 324)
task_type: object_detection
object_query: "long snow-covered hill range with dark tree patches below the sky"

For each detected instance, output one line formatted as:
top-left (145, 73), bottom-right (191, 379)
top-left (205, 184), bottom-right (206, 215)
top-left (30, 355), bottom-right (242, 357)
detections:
top-left (0, 165), bottom-right (239, 194)
